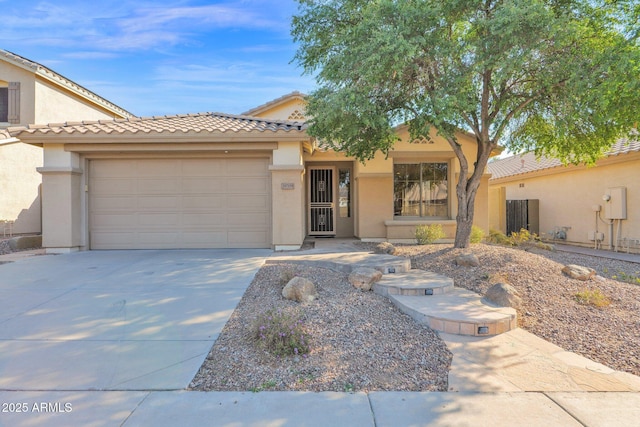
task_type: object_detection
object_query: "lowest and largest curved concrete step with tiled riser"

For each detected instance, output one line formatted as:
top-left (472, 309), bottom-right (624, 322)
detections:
top-left (388, 288), bottom-right (518, 336)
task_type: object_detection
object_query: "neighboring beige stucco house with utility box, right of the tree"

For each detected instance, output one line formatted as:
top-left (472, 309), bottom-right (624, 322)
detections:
top-left (488, 141), bottom-right (640, 252)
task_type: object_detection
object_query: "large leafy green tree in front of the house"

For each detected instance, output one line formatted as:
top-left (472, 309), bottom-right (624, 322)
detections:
top-left (292, 0), bottom-right (640, 247)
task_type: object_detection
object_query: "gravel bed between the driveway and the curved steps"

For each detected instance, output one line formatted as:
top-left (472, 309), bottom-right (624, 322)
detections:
top-left (190, 265), bottom-right (451, 391)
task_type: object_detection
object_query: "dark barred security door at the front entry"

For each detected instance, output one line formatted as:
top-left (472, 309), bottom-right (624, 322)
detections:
top-left (309, 168), bottom-right (336, 236)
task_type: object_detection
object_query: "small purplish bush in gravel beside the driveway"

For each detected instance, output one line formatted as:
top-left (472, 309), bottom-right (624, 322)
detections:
top-left (252, 310), bottom-right (309, 356)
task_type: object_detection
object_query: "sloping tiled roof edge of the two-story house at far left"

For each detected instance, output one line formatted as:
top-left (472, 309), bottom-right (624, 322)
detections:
top-left (0, 49), bottom-right (134, 117)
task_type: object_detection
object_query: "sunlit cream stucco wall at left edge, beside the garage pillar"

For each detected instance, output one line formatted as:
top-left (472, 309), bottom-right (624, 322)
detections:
top-left (0, 141), bottom-right (42, 234)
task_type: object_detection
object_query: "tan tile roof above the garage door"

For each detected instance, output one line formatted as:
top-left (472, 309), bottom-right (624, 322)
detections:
top-left (8, 113), bottom-right (307, 137)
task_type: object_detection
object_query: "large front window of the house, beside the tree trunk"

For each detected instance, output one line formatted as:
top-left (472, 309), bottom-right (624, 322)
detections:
top-left (393, 163), bottom-right (449, 218)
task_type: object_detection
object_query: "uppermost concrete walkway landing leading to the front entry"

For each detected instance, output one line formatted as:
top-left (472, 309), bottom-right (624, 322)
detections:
top-left (265, 251), bottom-right (411, 274)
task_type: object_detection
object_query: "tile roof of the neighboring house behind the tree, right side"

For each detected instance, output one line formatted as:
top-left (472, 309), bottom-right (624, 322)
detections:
top-left (487, 140), bottom-right (640, 180)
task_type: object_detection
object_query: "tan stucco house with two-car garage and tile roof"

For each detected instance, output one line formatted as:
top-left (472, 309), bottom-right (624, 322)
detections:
top-left (9, 92), bottom-right (489, 252)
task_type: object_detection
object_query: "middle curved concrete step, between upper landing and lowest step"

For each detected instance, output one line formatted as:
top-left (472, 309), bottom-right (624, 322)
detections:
top-left (373, 269), bottom-right (454, 296)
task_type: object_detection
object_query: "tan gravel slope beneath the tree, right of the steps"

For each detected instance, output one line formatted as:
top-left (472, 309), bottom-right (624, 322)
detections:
top-left (396, 244), bottom-right (640, 375)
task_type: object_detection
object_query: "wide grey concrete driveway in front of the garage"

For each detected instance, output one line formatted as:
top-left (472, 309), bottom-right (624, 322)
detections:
top-left (0, 250), bottom-right (271, 391)
